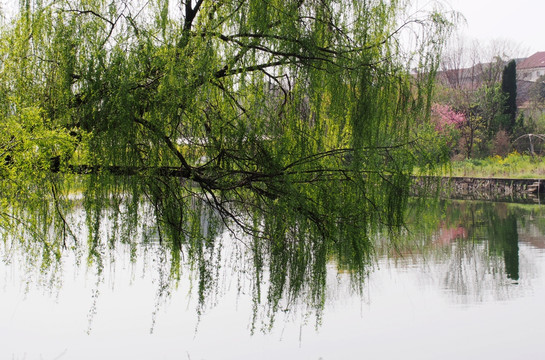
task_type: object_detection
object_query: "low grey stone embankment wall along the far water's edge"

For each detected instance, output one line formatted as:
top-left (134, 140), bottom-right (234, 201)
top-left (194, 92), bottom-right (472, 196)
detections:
top-left (415, 177), bottom-right (545, 202)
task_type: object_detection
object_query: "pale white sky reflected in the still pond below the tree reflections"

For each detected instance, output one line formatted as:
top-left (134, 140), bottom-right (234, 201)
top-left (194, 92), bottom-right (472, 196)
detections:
top-left (0, 202), bottom-right (545, 360)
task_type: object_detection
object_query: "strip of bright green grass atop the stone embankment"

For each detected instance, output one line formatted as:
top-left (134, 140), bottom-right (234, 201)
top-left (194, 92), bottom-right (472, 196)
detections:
top-left (443, 151), bottom-right (545, 179)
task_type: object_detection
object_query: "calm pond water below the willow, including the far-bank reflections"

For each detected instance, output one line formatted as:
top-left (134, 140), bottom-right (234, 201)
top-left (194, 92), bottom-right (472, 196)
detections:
top-left (0, 202), bottom-right (545, 360)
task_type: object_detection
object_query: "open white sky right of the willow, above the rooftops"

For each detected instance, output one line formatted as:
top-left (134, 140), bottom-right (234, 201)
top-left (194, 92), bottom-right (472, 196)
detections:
top-left (442, 0), bottom-right (545, 56)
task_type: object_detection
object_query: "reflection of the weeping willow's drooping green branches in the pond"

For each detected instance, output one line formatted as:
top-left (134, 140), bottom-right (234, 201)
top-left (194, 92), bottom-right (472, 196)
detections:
top-left (0, 176), bottom-right (378, 330)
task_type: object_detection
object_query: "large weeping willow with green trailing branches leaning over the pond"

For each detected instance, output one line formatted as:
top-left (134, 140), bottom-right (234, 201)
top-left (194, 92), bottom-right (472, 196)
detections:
top-left (0, 0), bottom-right (452, 326)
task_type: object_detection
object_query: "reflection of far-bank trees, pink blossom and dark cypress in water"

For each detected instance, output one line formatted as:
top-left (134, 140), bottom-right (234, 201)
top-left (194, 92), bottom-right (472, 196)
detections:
top-left (376, 201), bottom-right (545, 303)
